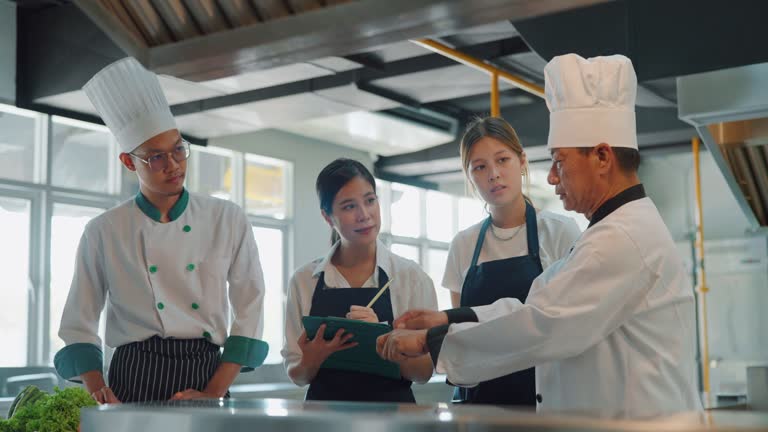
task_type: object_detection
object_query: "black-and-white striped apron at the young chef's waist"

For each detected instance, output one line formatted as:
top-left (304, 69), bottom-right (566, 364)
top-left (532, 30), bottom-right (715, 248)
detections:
top-left (109, 336), bottom-right (229, 402)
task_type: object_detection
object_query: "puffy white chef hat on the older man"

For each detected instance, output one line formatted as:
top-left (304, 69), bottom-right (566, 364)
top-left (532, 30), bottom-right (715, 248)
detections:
top-left (544, 54), bottom-right (637, 150)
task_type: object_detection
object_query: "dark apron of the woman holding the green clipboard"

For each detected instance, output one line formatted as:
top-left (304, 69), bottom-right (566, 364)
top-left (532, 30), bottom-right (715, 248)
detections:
top-left (306, 268), bottom-right (416, 402)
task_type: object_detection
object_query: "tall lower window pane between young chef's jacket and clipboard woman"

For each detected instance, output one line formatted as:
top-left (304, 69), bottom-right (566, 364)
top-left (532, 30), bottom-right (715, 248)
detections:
top-left (253, 227), bottom-right (285, 363)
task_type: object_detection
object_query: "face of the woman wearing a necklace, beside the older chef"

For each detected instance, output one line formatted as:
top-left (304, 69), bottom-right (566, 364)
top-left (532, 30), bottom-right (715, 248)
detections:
top-left (468, 137), bottom-right (525, 207)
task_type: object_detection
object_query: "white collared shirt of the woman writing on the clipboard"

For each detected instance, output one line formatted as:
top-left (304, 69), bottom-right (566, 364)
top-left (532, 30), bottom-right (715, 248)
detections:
top-left (281, 241), bottom-right (437, 382)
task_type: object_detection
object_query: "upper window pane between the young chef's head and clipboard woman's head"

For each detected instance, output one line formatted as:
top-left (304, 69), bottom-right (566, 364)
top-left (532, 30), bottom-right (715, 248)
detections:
top-left (245, 154), bottom-right (290, 219)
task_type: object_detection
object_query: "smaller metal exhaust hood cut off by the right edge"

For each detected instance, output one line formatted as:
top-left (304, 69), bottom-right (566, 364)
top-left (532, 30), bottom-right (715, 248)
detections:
top-left (677, 63), bottom-right (768, 229)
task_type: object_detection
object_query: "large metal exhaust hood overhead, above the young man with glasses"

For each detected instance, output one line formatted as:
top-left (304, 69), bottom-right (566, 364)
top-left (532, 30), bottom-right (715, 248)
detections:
top-left (74, 0), bottom-right (611, 81)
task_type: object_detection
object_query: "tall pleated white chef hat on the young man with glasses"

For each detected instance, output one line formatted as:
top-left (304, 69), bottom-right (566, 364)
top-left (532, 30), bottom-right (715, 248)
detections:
top-left (83, 57), bottom-right (176, 153)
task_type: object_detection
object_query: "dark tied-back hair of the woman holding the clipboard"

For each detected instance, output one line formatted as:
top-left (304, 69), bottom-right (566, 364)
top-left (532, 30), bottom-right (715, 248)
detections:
top-left (315, 158), bottom-right (376, 244)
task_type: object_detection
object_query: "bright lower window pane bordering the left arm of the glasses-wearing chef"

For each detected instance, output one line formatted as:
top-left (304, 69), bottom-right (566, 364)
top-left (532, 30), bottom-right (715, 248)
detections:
top-left (48, 203), bottom-right (104, 363)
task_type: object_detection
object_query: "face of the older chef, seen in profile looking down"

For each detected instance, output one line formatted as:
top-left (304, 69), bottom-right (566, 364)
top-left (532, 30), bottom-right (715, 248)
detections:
top-left (547, 148), bottom-right (599, 217)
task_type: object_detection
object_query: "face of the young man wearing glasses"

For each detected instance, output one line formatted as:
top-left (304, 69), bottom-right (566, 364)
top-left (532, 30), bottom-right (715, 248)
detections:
top-left (120, 129), bottom-right (189, 195)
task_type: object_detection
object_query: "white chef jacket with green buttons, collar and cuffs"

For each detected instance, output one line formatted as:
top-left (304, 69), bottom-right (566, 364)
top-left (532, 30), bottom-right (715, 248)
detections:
top-left (56, 190), bottom-right (266, 378)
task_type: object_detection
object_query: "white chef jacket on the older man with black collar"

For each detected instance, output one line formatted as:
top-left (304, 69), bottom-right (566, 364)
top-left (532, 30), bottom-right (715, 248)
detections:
top-left (437, 198), bottom-right (701, 418)
